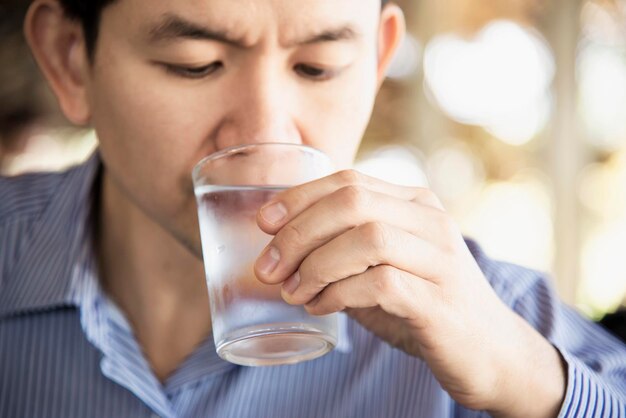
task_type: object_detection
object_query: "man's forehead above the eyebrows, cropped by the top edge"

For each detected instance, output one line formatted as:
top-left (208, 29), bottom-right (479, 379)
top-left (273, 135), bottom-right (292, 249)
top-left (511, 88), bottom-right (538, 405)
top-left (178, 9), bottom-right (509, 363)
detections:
top-left (103, 0), bottom-right (380, 43)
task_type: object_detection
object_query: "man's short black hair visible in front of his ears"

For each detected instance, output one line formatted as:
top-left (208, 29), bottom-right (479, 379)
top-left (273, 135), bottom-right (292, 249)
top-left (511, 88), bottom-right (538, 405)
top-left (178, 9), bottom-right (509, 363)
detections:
top-left (59, 0), bottom-right (389, 59)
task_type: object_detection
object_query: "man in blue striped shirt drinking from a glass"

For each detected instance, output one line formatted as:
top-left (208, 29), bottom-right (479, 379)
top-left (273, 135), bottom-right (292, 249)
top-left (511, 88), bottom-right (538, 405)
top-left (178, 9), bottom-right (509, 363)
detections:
top-left (0, 0), bottom-right (626, 417)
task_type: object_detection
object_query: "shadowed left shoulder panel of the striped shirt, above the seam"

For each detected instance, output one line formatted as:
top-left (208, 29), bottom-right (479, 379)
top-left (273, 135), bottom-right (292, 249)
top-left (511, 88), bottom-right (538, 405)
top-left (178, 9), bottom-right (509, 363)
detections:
top-left (0, 156), bottom-right (100, 317)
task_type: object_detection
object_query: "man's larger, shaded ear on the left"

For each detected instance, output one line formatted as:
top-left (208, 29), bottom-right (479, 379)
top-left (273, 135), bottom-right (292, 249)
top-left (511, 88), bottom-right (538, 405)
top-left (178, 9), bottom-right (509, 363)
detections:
top-left (24, 0), bottom-right (91, 125)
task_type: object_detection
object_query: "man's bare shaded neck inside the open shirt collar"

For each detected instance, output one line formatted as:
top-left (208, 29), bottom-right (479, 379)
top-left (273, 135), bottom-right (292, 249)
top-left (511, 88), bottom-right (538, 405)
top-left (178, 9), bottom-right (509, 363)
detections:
top-left (97, 170), bottom-right (211, 381)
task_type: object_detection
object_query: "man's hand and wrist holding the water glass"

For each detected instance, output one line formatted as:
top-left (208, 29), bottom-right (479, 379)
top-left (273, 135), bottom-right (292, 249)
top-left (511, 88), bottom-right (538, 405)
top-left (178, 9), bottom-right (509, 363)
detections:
top-left (255, 170), bottom-right (565, 417)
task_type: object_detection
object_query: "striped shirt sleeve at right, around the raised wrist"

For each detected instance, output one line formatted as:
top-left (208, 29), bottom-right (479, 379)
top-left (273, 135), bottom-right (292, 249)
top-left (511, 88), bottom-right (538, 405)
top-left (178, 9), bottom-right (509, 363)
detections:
top-left (468, 243), bottom-right (626, 418)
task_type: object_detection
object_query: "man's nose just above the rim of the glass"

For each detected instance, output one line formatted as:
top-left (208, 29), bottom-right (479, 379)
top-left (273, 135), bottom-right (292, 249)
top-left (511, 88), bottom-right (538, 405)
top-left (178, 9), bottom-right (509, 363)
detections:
top-left (216, 62), bottom-right (302, 149)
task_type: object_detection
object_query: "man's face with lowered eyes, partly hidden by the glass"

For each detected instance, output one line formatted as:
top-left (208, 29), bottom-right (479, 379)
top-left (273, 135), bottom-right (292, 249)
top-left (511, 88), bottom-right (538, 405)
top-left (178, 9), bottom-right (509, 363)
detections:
top-left (87, 0), bottom-right (380, 254)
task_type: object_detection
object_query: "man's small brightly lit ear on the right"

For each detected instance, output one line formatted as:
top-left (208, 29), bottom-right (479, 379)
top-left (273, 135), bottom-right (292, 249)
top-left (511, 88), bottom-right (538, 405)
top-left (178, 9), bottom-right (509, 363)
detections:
top-left (378, 3), bottom-right (406, 87)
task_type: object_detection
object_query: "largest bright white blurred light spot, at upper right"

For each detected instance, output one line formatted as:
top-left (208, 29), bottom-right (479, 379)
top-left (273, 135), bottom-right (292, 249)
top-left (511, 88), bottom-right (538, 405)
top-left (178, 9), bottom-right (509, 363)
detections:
top-left (424, 20), bottom-right (554, 145)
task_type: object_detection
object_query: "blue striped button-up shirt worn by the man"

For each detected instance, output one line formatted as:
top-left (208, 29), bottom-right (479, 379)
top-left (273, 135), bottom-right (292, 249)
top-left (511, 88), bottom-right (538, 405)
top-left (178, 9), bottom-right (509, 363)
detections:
top-left (0, 153), bottom-right (626, 418)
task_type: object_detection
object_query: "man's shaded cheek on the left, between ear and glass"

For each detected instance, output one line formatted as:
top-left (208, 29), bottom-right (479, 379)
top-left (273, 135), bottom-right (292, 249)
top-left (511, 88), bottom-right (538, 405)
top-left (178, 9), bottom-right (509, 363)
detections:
top-left (91, 57), bottom-right (219, 224)
